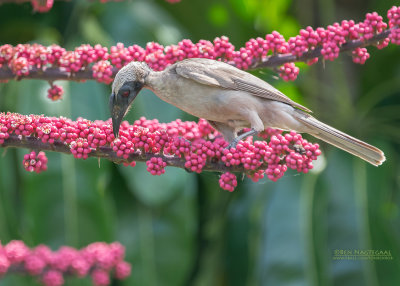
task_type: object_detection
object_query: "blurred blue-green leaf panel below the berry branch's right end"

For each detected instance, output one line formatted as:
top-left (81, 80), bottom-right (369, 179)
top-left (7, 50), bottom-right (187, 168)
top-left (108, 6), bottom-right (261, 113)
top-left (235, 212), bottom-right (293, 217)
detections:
top-left (258, 172), bottom-right (310, 285)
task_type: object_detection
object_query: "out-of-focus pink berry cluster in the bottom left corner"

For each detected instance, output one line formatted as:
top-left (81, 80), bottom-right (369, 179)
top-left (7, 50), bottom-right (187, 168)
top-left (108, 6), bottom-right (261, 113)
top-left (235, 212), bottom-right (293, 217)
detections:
top-left (0, 240), bottom-right (131, 286)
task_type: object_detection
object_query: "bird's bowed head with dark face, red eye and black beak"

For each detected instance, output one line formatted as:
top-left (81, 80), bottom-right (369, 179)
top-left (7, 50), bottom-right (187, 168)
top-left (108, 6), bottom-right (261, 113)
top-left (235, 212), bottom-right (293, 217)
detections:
top-left (109, 62), bottom-right (151, 138)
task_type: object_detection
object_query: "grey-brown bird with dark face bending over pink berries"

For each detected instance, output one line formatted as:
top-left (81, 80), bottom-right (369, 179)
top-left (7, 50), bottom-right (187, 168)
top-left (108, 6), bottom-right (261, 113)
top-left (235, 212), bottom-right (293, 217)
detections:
top-left (109, 58), bottom-right (386, 166)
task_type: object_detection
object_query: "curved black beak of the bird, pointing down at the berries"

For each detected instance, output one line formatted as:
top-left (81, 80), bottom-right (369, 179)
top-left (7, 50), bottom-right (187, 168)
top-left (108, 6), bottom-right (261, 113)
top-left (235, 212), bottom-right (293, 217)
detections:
top-left (109, 90), bottom-right (138, 138)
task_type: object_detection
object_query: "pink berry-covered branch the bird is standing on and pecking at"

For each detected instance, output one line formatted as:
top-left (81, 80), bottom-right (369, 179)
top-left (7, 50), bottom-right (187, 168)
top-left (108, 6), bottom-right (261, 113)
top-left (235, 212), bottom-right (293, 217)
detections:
top-left (0, 113), bottom-right (321, 190)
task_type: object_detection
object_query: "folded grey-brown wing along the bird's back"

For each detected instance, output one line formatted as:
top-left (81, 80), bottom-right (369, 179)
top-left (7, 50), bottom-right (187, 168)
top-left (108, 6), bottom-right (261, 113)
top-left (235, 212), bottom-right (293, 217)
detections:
top-left (175, 58), bottom-right (311, 112)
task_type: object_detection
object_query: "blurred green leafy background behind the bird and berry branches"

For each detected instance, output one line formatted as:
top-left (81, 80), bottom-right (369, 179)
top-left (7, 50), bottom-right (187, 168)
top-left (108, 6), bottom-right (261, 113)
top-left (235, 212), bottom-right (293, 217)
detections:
top-left (0, 0), bottom-right (400, 286)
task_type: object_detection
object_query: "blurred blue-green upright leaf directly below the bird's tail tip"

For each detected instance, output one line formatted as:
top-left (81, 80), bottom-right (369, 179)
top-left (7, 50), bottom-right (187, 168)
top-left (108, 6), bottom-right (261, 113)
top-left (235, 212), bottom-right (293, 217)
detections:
top-left (320, 150), bottom-right (367, 285)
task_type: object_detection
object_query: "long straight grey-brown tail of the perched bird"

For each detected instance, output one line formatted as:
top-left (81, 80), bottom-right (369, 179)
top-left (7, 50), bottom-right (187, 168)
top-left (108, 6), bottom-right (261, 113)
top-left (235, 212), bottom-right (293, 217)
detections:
top-left (295, 110), bottom-right (386, 166)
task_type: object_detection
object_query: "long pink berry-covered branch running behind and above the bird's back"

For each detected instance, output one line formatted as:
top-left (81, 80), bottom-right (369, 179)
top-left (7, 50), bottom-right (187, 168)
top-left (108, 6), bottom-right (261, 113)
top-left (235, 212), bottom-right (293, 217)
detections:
top-left (0, 6), bottom-right (400, 84)
